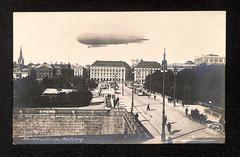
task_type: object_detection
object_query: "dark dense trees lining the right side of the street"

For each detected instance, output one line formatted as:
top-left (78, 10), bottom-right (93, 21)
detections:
top-left (145, 64), bottom-right (225, 107)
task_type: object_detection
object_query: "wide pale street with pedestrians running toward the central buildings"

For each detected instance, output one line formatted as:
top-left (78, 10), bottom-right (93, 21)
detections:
top-left (118, 86), bottom-right (224, 143)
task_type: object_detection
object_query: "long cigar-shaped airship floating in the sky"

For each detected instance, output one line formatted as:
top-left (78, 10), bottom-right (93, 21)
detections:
top-left (77, 34), bottom-right (149, 48)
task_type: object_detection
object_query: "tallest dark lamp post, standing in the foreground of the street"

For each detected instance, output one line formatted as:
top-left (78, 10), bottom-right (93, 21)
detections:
top-left (161, 48), bottom-right (167, 141)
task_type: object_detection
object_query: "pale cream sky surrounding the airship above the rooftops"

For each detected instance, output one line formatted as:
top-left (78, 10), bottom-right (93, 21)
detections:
top-left (13, 11), bottom-right (226, 66)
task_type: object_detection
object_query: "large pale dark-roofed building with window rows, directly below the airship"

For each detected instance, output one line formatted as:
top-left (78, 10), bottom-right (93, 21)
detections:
top-left (90, 60), bottom-right (131, 81)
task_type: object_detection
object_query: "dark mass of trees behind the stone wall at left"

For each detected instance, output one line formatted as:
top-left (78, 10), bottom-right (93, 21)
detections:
top-left (14, 71), bottom-right (97, 107)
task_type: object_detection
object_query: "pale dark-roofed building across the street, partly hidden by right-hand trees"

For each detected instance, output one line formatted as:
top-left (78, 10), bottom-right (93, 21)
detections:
top-left (134, 59), bottom-right (161, 84)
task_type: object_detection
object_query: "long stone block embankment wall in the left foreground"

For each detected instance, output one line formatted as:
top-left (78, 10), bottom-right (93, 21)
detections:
top-left (13, 109), bottom-right (139, 137)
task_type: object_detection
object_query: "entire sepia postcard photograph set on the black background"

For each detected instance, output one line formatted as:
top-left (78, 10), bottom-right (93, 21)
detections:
top-left (11, 11), bottom-right (226, 145)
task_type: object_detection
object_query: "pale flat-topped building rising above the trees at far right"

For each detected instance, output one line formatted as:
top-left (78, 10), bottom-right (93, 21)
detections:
top-left (194, 54), bottom-right (225, 65)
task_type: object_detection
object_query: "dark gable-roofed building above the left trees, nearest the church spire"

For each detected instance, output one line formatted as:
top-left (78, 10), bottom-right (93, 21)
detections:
top-left (34, 63), bottom-right (53, 81)
